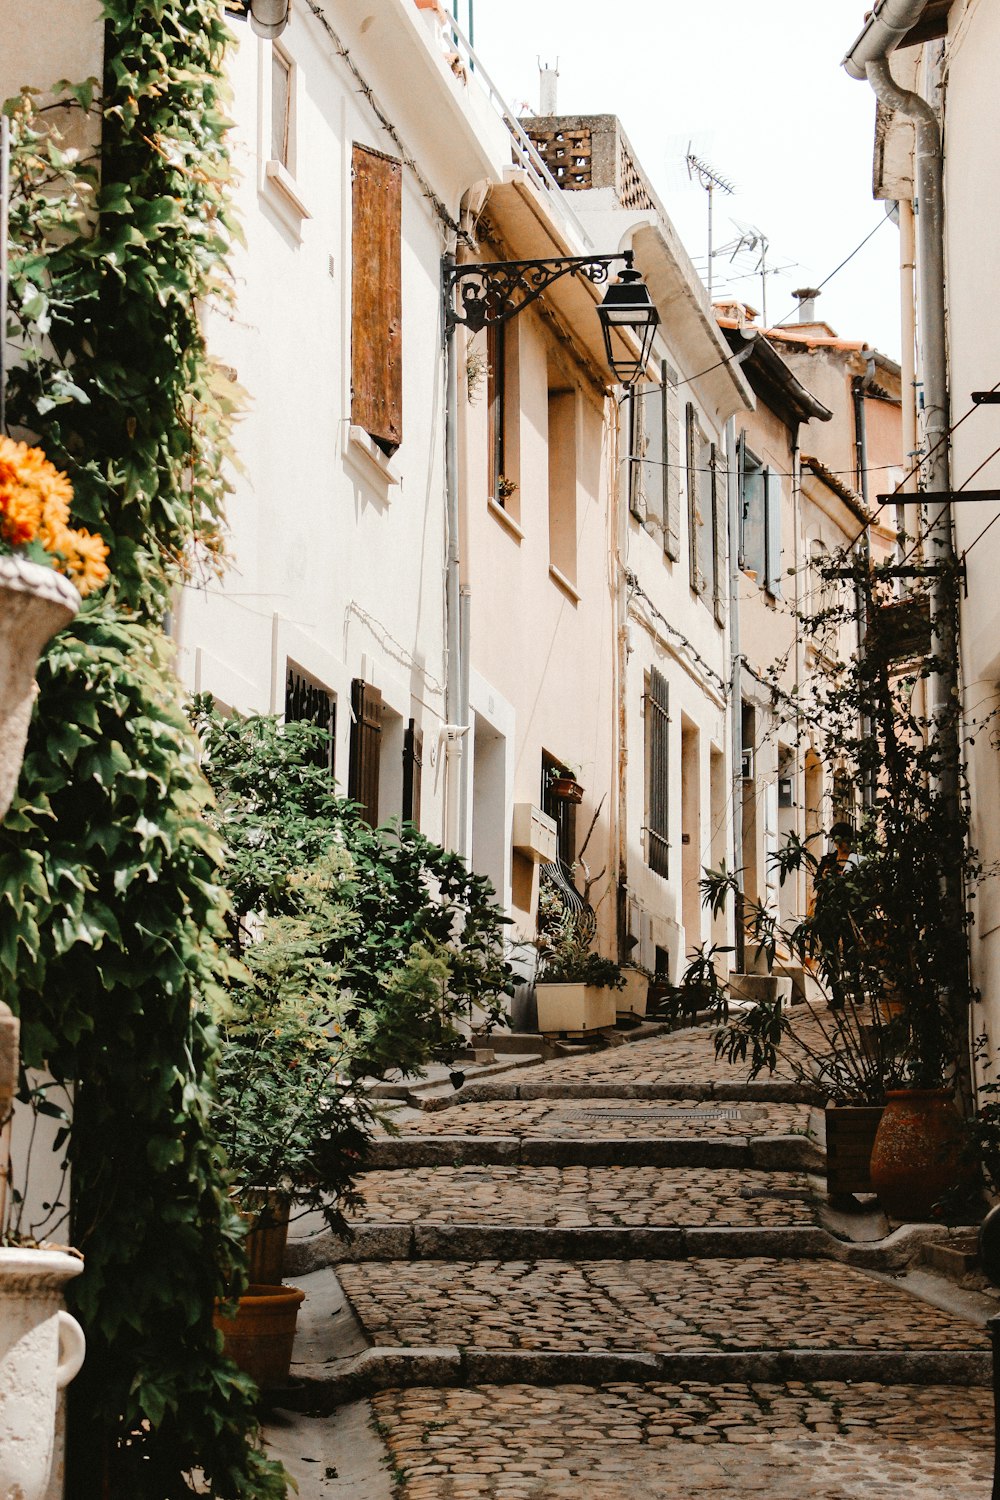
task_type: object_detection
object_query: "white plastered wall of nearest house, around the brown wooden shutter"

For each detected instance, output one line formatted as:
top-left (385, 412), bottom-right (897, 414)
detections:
top-left (174, 0), bottom-right (509, 839)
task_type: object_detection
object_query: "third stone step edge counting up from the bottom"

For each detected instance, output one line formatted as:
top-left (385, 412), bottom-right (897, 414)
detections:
top-left (363, 1134), bottom-right (826, 1172)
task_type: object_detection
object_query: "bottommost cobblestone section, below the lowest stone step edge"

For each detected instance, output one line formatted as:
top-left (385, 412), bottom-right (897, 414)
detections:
top-left (373, 1383), bottom-right (993, 1500)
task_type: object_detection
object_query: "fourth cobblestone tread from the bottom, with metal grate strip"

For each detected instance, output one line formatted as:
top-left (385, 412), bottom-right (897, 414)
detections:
top-left (380, 1100), bottom-right (810, 1140)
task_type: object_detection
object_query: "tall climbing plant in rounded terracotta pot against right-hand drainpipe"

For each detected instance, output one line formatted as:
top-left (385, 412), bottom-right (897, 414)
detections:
top-left (659, 560), bottom-right (979, 1218)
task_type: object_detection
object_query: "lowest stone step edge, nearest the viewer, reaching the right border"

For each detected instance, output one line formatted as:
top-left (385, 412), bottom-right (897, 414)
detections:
top-left (279, 1347), bottom-right (993, 1415)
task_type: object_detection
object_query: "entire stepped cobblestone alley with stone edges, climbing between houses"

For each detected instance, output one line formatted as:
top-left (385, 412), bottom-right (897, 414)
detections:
top-left (271, 1031), bottom-right (993, 1500)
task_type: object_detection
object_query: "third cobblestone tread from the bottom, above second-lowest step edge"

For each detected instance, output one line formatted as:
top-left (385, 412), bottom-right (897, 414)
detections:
top-left (352, 1167), bottom-right (819, 1229)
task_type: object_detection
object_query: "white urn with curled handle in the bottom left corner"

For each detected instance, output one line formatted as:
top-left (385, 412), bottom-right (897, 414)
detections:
top-left (0, 1250), bottom-right (85, 1500)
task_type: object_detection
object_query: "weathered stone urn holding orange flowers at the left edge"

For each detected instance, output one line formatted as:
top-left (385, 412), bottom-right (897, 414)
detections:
top-left (0, 557), bottom-right (79, 818)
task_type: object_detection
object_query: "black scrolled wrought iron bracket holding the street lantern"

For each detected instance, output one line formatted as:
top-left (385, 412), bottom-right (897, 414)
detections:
top-left (444, 251), bottom-right (633, 333)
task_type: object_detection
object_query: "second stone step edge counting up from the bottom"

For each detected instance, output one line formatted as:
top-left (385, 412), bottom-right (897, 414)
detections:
top-left (285, 1224), bottom-right (948, 1277)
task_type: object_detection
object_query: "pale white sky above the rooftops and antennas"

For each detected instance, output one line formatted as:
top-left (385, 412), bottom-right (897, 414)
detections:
top-left (461, 0), bottom-right (900, 359)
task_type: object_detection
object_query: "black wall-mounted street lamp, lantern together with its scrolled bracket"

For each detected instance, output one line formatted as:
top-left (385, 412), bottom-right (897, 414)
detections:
top-left (444, 251), bottom-right (660, 386)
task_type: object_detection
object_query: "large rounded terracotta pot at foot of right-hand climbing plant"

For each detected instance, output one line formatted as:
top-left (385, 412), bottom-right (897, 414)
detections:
top-left (871, 1089), bottom-right (967, 1223)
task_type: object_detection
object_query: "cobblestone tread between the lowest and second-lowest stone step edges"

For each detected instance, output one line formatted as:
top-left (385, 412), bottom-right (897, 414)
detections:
top-left (339, 1257), bottom-right (987, 1353)
